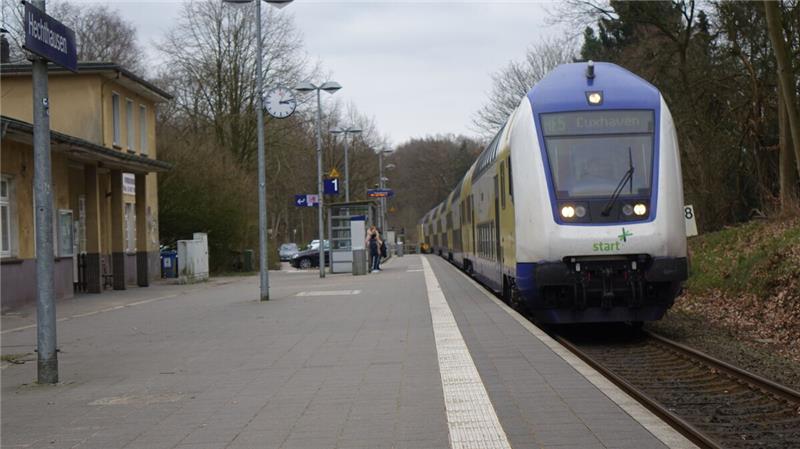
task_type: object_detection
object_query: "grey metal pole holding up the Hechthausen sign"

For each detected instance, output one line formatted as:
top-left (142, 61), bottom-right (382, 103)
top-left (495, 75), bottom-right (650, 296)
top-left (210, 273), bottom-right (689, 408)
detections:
top-left (33, 0), bottom-right (58, 384)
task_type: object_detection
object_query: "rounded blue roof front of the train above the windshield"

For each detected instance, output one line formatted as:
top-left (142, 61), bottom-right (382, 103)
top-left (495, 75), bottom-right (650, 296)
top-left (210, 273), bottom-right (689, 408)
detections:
top-left (528, 62), bottom-right (661, 113)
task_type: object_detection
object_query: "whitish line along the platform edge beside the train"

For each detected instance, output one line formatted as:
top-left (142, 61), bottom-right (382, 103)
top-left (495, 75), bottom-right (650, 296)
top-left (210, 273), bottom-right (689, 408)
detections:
top-left (450, 260), bottom-right (697, 449)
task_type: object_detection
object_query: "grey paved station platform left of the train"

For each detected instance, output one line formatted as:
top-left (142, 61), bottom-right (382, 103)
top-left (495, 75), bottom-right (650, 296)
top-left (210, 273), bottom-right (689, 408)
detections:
top-left (2, 255), bottom-right (694, 449)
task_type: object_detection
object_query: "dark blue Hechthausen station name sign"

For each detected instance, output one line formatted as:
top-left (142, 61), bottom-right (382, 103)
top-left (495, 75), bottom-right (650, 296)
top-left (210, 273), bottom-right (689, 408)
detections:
top-left (22, 2), bottom-right (78, 72)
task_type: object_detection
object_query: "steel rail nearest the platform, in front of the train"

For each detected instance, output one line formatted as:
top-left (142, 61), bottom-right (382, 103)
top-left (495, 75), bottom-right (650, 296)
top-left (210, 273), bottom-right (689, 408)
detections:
top-left (552, 335), bottom-right (723, 449)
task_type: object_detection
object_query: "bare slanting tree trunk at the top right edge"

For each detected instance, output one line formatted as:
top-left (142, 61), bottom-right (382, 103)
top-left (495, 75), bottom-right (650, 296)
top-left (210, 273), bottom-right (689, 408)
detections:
top-left (764, 0), bottom-right (800, 178)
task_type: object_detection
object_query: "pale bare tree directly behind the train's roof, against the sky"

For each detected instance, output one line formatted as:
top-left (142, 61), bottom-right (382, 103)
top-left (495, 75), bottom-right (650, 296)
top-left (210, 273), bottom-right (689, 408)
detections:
top-left (472, 37), bottom-right (577, 138)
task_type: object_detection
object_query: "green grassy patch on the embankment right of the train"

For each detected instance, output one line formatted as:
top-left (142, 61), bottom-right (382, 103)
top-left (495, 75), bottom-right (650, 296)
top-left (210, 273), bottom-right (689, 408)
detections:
top-left (687, 219), bottom-right (800, 298)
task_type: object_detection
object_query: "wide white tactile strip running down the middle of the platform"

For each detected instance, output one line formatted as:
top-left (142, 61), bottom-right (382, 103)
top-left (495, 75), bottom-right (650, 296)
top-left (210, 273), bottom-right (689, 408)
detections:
top-left (422, 258), bottom-right (511, 449)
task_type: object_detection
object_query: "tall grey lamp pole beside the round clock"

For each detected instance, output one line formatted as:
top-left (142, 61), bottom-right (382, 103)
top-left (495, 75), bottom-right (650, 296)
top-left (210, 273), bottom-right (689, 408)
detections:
top-left (256, 0), bottom-right (269, 301)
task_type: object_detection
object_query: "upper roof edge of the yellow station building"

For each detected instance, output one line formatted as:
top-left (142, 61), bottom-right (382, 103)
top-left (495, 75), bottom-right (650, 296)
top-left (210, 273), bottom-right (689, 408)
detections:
top-left (0, 62), bottom-right (173, 102)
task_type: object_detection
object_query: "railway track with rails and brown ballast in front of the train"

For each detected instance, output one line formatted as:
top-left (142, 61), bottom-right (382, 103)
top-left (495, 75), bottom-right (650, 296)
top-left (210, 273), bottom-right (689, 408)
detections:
top-left (554, 326), bottom-right (800, 449)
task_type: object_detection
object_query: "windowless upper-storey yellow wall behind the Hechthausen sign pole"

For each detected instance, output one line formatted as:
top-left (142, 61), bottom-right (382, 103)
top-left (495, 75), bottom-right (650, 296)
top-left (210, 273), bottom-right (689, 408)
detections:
top-left (0, 75), bottom-right (103, 144)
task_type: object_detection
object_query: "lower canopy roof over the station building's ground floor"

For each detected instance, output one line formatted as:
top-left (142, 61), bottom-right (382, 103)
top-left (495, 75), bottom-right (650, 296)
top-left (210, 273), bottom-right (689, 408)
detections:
top-left (0, 115), bottom-right (173, 173)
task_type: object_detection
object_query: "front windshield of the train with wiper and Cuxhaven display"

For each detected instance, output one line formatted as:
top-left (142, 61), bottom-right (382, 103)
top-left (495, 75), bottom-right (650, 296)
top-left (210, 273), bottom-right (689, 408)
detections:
top-left (541, 110), bottom-right (654, 199)
